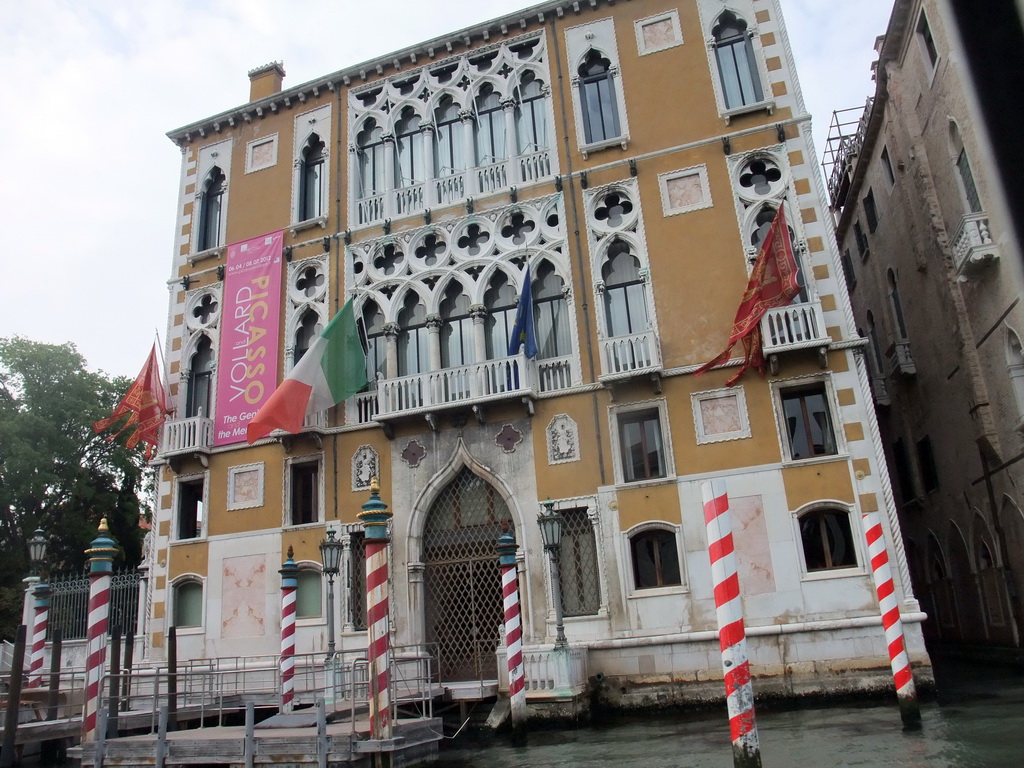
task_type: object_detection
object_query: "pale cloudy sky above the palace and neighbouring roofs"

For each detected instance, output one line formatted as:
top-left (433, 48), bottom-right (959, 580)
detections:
top-left (0, 0), bottom-right (892, 377)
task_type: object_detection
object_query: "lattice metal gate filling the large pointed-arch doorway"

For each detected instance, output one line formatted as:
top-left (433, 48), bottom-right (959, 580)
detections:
top-left (423, 468), bottom-right (511, 681)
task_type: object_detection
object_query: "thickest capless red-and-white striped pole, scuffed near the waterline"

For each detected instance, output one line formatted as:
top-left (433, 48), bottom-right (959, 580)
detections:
top-left (700, 479), bottom-right (761, 768)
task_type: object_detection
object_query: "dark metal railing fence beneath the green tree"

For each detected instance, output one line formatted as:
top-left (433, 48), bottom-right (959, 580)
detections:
top-left (46, 568), bottom-right (140, 640)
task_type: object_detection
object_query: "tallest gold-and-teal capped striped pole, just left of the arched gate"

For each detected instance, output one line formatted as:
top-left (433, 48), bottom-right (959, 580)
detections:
top-left (357, 477), bottom-right (392, 753)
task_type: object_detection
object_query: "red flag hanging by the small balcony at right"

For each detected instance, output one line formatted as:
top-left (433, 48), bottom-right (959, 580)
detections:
top-left (696, 206), bottom-right (800, 387)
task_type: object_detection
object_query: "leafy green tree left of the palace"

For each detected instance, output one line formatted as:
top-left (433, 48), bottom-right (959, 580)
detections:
top-left (0, 337), bottom-right (151, 638)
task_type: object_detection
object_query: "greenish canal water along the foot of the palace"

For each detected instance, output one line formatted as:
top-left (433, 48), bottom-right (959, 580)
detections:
top-left (440, 662), bottom-right (1024, 768)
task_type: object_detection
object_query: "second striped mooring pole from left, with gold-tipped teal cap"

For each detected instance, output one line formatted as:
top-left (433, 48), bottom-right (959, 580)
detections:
top-left (82, 517), bottom-right (118, 741)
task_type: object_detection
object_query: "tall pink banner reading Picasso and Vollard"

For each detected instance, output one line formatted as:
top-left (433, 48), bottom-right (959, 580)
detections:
top-left (213, 231), bottom-right (285, 445)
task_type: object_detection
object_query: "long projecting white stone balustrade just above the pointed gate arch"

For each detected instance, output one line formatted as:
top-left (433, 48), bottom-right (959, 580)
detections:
top-left (376, 354), bottom-right (536, 419)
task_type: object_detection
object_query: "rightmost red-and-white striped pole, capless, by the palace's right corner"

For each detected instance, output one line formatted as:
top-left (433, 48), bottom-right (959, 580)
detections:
top-left (860, 512), bottom-right (921, 728)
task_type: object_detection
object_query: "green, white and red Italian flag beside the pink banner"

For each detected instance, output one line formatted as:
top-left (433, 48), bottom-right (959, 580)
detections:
top-left (246, 299), bottom-right (367, 443)
